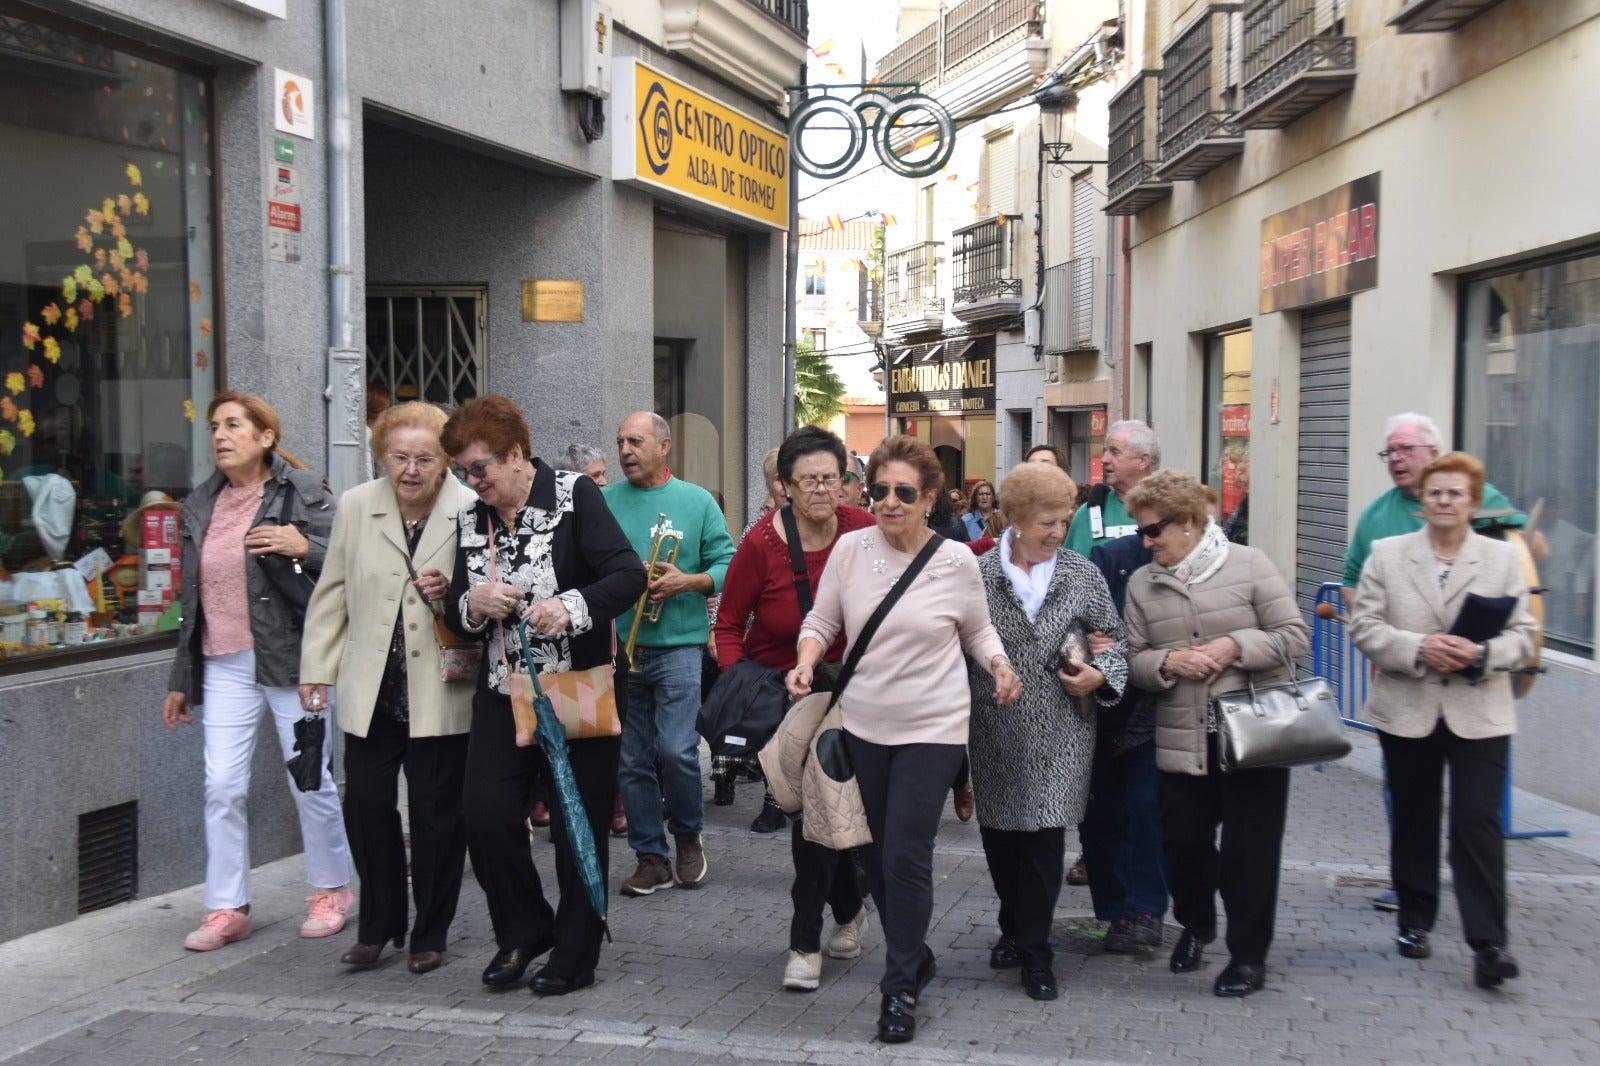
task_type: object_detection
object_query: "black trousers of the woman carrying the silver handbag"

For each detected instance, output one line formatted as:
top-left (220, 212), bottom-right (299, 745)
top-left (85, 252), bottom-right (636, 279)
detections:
top-left (1160, 733), bottom-right (1290, 965)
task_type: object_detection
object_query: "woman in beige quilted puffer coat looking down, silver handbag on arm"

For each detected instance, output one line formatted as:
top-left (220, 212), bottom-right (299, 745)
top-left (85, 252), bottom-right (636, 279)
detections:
top-left (1123, 471), bottom-right (1310, 996)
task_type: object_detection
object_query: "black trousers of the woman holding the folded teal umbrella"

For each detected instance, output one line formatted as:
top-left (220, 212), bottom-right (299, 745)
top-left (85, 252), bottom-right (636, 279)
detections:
top-left (464, 690), bottom-right (622, 978)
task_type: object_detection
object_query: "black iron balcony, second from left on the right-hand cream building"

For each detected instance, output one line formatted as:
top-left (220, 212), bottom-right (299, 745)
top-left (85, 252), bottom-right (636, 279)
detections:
top-left (1157, 3), bottom-right (1245, 181)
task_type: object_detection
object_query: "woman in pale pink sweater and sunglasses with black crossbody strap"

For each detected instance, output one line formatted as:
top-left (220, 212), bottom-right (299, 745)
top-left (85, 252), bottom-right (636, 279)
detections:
top-left (786, 437), bottom-right (1022, 1044)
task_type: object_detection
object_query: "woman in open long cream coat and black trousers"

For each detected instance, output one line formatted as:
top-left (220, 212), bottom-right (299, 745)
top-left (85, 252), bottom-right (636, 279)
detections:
top-left (299, 403), bottom-right (472, 973)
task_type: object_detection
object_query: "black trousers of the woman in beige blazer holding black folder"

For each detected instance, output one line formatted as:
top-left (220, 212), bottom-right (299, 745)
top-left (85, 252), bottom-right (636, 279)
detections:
top-left (1378, 719), bottom-right (1510, 944)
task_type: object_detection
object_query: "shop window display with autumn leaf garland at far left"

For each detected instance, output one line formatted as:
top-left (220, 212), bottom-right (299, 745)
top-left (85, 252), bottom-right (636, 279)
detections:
top-left (0, 14), bottom-right (218, 667)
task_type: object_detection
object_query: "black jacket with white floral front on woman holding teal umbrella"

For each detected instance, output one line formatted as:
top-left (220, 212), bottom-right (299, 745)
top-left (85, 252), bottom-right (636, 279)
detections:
top-left (445, 459), bottom-right (645, 696)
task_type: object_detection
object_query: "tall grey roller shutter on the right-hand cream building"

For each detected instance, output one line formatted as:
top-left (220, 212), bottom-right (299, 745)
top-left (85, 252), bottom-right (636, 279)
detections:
top-left (1294, 303), bottom-right (1350, 611)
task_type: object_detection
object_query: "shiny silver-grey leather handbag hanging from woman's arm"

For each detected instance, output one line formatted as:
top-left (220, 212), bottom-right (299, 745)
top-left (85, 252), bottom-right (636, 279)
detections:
top-left (1211, 648), bottom-right (1350, 773)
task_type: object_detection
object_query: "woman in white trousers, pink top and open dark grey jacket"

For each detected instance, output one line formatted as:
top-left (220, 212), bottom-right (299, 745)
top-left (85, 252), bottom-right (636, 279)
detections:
top-left (162, 392), bottom-right (355, 951)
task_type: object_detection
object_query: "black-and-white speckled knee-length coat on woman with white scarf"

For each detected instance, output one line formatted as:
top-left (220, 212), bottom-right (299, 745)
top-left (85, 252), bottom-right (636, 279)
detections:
top-left (966, 547), bottom-right (1128, 832)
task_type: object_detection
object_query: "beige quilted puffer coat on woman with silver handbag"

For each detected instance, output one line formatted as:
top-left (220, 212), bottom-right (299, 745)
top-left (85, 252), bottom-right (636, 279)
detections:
top-left (1123, 544), bottom-right (1310, 776)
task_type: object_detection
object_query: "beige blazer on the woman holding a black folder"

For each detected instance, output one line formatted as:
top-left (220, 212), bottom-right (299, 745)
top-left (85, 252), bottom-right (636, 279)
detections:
top-left (1350, 530), bottom-right (1538, 739)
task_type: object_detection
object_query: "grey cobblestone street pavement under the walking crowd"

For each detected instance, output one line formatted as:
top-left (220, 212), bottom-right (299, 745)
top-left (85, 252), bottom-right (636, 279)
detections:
top-left (0, 736), bottom-right (1600, 1066)
